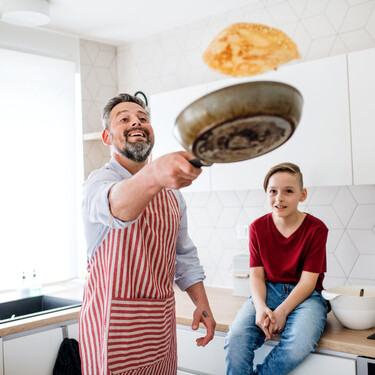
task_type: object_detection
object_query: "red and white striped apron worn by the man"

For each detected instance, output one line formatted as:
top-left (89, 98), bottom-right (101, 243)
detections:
top-left (79, 189), bottom-right (181, 375)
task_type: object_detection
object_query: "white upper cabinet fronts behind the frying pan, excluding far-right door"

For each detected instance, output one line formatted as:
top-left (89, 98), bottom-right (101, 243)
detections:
top-left (151, 55), bottom-right (352, 191)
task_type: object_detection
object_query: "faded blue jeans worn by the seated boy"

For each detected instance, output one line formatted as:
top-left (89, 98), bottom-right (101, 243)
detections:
top-left (225, 282), bottom-right (328, 375)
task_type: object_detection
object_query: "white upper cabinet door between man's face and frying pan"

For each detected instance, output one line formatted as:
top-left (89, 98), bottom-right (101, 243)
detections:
top-left (150, 85), bottom-right (211, 191)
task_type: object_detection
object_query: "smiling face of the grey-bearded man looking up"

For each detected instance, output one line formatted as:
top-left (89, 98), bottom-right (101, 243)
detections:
top-left (109, 102), bottom-right (154, 162)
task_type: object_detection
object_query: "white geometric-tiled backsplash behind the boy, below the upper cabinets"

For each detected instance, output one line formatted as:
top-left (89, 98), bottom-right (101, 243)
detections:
top-left (184, 185), bottom-right (375, 288)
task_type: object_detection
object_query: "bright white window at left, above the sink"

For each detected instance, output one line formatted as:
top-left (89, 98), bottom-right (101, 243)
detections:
top-left (0, 49), bottom-right (84, 290)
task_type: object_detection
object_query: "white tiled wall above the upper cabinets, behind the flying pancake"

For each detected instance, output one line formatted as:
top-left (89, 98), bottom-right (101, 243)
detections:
top-left (118, 0), bottom-right (375, 95)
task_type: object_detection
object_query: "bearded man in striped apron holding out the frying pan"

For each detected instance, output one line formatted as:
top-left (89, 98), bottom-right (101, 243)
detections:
top-left (79, 94), bottom-right (216, 375)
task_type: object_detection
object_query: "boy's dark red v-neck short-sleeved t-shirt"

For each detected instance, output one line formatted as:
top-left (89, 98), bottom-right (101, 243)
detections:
top-left (249, 214), bottom-right (328, 290)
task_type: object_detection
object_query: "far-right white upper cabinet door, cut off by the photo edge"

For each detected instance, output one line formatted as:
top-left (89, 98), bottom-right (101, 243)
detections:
top-left (348, 48), bottom-right (375, 185)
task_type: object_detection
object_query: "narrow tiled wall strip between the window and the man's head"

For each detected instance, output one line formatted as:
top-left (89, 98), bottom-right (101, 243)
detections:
top-left (80, 40), bottom-right (117, 178)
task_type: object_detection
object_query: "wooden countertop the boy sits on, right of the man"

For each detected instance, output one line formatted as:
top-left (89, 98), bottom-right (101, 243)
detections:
top-left (175, 287), bottom-right (375, 357)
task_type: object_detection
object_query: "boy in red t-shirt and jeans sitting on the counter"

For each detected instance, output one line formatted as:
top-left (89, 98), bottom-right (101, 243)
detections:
top-left (225, 163), bottom-right (328, 375)
